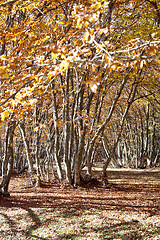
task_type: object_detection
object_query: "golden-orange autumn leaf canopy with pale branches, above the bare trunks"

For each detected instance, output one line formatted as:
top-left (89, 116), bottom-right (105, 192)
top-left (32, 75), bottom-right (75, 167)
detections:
top-left (0, 0), bottom-right (160, 121)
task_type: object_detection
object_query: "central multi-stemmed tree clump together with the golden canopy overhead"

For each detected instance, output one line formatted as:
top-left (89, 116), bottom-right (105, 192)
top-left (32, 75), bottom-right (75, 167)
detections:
top-left (0, 0), bottom-right (160, 191)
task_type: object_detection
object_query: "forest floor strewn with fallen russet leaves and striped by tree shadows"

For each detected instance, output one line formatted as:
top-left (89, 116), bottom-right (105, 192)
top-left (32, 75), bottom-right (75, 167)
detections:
top-left (0, 169), bottom-right (160, 240)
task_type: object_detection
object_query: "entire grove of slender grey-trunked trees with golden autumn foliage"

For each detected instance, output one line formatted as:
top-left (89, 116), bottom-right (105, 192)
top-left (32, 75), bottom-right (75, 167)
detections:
top-left (0, 0), bottom-right (160, 192)
